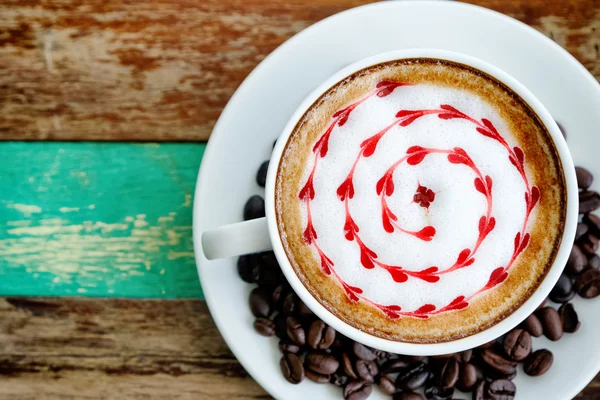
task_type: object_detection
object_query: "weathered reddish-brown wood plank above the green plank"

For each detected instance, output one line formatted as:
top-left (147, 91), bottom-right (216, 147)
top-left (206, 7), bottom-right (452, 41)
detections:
top-left (0, 0), bottom-right (600, 141)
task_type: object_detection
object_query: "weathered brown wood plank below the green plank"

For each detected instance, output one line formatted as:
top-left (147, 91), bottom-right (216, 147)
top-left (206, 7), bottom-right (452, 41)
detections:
top-left (0, 297), bottom-right (600, 400)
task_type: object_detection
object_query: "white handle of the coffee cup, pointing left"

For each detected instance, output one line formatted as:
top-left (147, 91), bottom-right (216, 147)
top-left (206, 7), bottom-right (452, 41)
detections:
top-left (202, 217), bottom-right (273, 260)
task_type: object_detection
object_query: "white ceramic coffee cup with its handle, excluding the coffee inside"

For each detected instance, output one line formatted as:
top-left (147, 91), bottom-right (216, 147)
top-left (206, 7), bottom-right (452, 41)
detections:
top-left (201, 49), bottom-right (578, 355)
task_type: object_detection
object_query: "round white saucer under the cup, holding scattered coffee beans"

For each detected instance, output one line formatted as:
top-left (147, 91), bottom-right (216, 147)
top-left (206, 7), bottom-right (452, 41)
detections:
top-left (194, 1), bottom-right (600, 400)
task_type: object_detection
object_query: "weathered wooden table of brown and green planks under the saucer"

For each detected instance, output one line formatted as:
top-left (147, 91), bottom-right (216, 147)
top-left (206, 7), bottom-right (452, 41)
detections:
top-left (0, 0), bottom-right (600, 400)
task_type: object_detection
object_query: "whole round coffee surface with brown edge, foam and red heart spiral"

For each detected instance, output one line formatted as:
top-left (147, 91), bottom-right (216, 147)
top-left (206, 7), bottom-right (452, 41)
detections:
top-left (275, 59), bottom-right (566, 343)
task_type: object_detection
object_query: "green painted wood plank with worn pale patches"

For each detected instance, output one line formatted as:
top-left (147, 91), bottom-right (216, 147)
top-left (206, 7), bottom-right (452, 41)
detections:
top-left (0, 142), bottom-right (205, 298)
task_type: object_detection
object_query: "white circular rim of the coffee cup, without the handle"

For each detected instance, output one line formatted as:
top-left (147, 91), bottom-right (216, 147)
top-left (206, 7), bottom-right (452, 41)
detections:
top-left (265, 49), bottom-right (578, 356)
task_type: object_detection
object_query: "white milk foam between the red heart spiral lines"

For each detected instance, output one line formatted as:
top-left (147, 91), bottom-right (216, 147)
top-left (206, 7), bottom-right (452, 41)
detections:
top-left (301, 84), bottom-right (535, 311)
